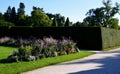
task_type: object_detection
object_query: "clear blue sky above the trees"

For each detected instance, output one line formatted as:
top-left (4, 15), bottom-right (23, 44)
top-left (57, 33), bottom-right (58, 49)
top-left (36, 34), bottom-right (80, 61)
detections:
top-left (0, 0), bottom-right (120, 22)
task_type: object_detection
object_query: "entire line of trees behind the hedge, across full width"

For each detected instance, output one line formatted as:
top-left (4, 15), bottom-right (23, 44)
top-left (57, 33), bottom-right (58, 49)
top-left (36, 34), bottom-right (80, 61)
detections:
top-left (0, 0), bottom-right (120, 29)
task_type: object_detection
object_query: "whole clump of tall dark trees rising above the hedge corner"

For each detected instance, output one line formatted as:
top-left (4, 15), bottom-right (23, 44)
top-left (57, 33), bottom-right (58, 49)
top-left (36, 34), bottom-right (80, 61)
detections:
top-left (83, 0), bottom-right (120, 28)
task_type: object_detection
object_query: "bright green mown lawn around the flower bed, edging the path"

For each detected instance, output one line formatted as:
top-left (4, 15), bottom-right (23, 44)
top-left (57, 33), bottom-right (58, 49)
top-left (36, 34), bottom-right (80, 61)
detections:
top-left (0, 46), bottom-right (94, 74)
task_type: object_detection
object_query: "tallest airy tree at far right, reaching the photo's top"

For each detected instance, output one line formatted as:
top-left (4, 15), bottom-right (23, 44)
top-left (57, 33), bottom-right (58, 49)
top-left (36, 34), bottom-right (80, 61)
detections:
top-left (103, 0), bottom-right (120, 27)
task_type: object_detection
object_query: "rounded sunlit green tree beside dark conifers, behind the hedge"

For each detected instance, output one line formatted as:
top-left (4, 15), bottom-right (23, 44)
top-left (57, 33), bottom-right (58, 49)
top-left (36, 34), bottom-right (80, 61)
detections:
top-left (31, 7), bottom-right (52, 27)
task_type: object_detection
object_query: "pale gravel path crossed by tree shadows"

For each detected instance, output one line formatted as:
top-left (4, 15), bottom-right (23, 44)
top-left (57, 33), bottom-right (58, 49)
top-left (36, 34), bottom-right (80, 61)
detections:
top-left (23, 48), bottom-right (120, 74)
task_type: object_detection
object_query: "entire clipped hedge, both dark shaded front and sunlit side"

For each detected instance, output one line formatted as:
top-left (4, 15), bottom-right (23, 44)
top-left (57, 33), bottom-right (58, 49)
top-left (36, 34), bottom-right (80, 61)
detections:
top-left (0, 27), bottom-right (120, 50)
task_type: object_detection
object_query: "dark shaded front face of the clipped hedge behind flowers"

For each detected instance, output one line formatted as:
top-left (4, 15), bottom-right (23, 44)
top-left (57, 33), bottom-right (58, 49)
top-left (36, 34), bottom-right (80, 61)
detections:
top-left (0, 27), bottom-right (102, 50)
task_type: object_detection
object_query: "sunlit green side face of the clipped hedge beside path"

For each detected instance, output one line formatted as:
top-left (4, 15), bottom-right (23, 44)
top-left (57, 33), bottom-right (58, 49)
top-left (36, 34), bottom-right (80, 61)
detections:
top-left (101, 28), bottom-right (120, 49)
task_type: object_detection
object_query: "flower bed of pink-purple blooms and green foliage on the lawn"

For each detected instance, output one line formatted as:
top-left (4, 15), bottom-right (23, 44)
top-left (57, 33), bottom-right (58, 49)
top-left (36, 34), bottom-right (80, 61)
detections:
top-left (5, 37), bottom-right (79, 62)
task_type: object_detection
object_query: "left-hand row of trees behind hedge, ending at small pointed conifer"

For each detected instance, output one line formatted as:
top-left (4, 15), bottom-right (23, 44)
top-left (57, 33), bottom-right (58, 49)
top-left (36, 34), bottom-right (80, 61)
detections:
top-left (0, 3), bottom-right (70, 27)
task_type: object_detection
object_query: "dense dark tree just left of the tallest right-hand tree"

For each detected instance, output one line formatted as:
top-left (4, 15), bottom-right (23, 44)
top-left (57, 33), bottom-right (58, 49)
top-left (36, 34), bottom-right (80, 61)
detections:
top-left (83, 7), bottom-right (104, 26)
